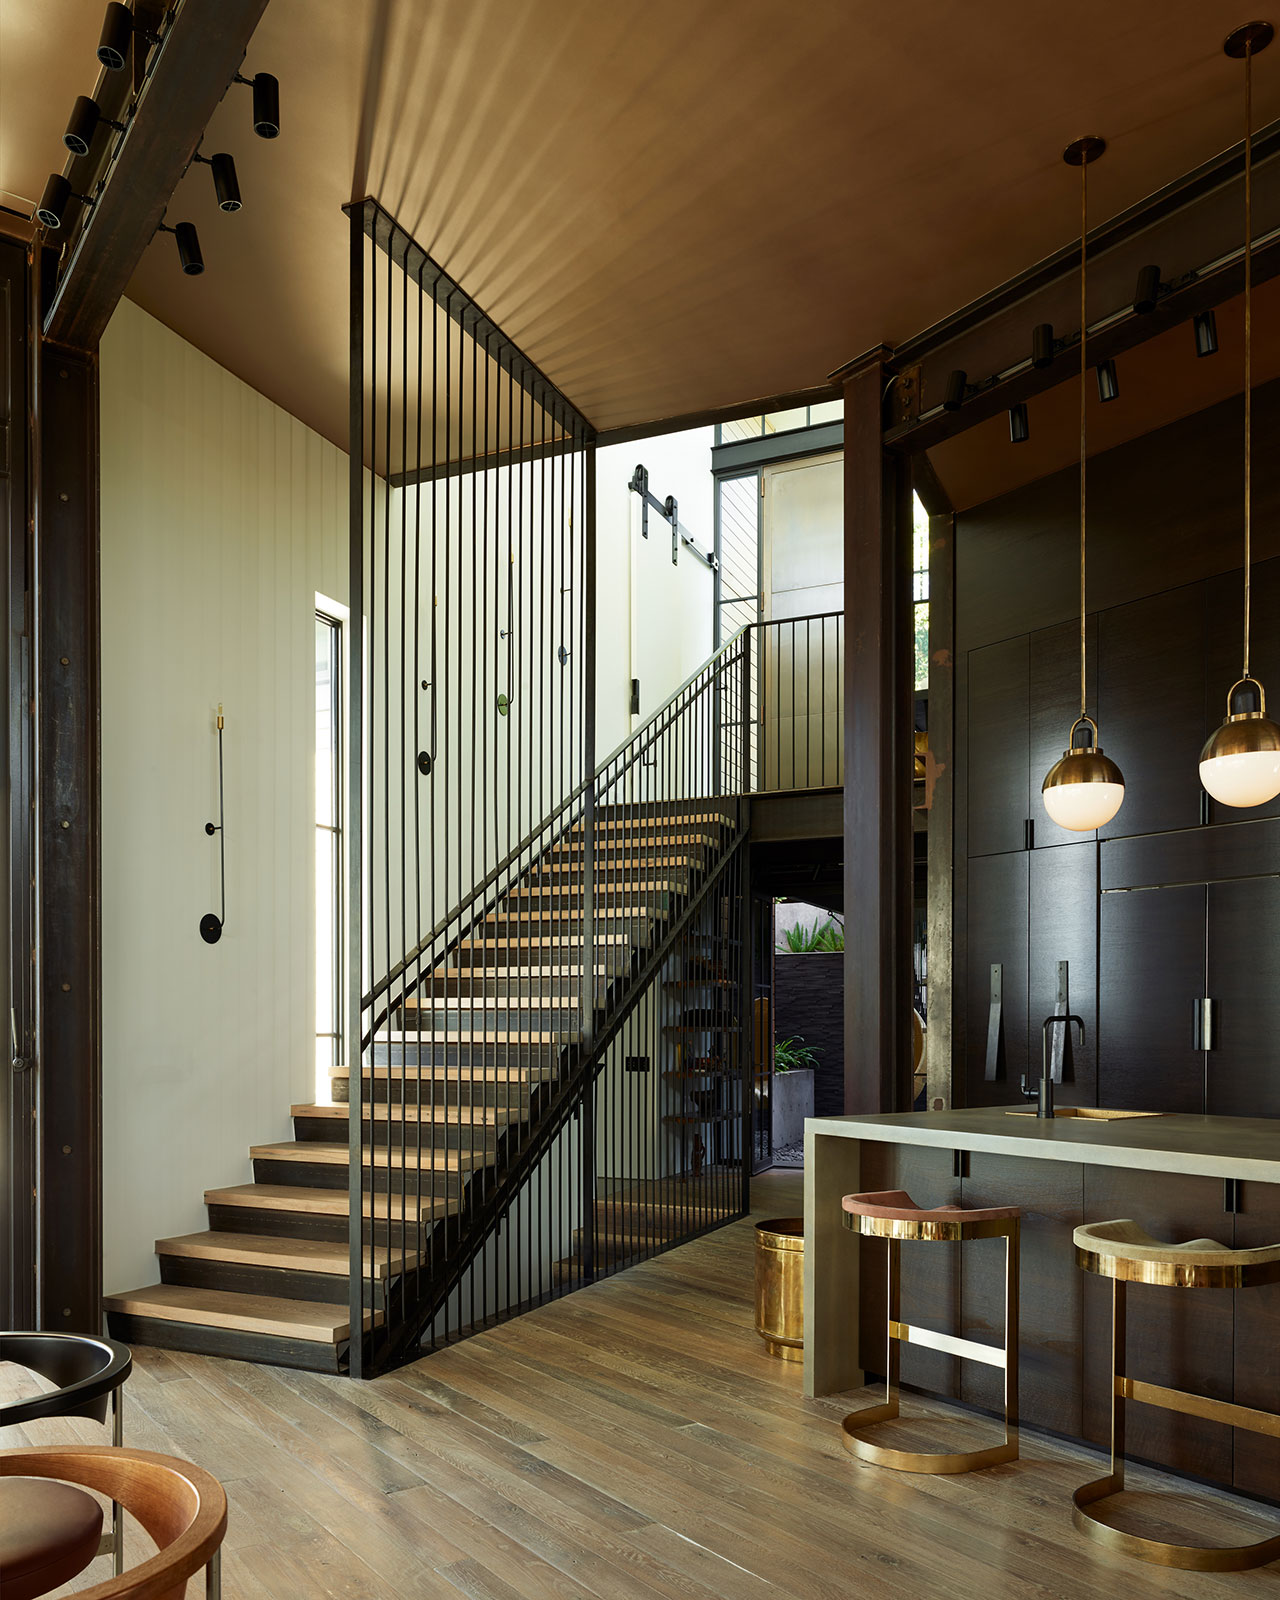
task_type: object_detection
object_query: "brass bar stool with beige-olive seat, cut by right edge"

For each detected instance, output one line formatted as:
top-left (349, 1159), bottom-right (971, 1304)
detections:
top-left (1072, 1221), bottom-right (1280, 1573)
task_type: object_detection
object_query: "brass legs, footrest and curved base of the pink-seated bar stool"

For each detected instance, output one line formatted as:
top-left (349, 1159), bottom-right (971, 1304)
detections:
top-left (840, 1213), bottom-right (1021, 1474)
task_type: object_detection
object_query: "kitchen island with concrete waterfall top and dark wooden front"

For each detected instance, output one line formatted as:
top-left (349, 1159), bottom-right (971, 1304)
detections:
top-left (805, 1106), bottom-right (1280, 1502)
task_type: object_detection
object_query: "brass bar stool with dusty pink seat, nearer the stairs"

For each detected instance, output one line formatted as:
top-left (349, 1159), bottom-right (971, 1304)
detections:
top-left (840, 1189), bottom-right (1021, 1472)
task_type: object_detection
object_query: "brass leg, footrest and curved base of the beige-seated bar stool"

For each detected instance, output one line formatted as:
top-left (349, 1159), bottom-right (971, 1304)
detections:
top-left (1070, 1280), bottom-right (1280, 1573)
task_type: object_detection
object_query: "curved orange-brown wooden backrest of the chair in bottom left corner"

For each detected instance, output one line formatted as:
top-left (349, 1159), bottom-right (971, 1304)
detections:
top-left (0, 1445), bottom-right (227, 1600)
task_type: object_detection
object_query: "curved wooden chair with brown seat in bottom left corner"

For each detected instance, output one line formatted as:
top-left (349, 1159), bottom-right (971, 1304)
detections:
top-left (0, 1445), bottom-right (227, 1600)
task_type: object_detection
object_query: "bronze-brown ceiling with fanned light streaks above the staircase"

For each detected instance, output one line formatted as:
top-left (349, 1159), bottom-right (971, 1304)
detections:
top-left (0, 0), bottom-right (1280, 448)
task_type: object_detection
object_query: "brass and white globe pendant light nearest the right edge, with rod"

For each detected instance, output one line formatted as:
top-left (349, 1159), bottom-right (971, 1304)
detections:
top-left (1200, 22), bottom-right (1280, 806)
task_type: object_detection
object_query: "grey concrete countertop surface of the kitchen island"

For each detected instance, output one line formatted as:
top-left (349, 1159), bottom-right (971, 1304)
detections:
top-left (805, 1106), bottom-right (1280, 1184)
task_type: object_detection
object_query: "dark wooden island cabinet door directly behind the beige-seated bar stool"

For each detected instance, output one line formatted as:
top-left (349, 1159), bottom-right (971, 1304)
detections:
top-left (1080, 1166), bottom-right (1235, 1483)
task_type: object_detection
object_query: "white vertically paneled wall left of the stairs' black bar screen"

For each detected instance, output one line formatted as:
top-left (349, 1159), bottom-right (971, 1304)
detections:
top-left (101, 302), bottom-right (347, 1291)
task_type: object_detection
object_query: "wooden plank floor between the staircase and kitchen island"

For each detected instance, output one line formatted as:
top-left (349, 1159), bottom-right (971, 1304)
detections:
top-left (0, 1173), bottom-right (1280, 1600)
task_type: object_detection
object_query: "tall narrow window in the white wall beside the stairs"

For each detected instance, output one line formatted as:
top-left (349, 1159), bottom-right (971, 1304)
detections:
top-left (315, 611), bottom-right (342, 1101)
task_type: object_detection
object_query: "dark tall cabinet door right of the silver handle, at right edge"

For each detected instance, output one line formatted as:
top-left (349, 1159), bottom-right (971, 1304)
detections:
top-left (1205, 876), bottom-right (1280, 1113)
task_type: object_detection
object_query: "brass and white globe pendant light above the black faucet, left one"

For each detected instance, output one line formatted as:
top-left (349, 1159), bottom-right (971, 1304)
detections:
top-left (1040, 136), bottom-right (1125, 834)
